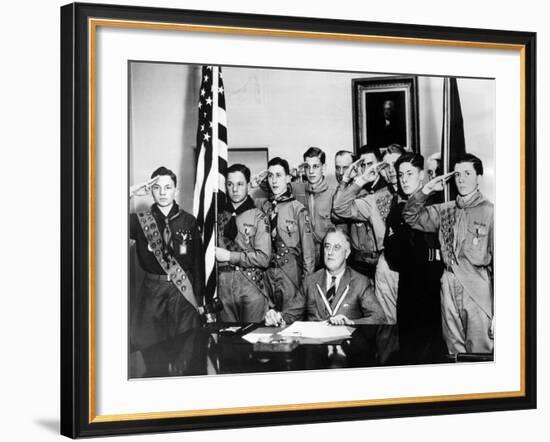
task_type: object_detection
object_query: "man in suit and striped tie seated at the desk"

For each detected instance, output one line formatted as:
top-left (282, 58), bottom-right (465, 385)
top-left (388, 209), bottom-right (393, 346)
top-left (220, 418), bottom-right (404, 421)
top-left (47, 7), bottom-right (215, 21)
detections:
top-left (289, 228), bottom-right (386, 325)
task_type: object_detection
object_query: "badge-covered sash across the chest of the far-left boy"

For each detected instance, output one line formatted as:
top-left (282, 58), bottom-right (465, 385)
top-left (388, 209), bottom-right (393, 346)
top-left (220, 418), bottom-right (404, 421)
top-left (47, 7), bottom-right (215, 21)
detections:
top-left (138, 210), bottom-right (200, 313)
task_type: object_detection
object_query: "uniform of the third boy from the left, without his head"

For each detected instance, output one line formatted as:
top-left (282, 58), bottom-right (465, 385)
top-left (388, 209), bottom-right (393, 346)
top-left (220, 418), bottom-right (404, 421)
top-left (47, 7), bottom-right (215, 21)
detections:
top-left (263, 198), bottom-right (315, 322)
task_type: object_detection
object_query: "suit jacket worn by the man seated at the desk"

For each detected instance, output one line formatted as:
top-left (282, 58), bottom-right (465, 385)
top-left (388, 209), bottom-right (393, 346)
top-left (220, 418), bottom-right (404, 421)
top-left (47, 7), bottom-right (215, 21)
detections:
top-left (284, 267), bottom-right (386, 324)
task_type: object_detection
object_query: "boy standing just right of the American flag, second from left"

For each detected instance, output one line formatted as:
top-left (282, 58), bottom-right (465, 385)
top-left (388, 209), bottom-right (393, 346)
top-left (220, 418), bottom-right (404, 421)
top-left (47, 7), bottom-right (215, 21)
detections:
top-left (216, 164), bottom-right (271, 322)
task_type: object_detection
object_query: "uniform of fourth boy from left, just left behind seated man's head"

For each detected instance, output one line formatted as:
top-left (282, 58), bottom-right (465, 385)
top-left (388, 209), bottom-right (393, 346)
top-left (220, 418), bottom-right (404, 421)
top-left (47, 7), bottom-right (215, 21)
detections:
top-left (305, 177), bottom-right (336, 268)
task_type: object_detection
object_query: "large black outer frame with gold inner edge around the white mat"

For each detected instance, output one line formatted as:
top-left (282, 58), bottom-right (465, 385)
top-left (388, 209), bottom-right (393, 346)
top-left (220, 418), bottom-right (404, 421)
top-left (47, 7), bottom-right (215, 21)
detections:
top-left (60, 3), bottom-right (537, 438)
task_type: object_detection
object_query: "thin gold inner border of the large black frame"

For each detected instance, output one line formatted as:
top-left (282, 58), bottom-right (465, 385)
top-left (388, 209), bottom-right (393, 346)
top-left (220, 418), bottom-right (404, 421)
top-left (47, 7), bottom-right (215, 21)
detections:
top-left (88, 18), bottom-right (526, 423)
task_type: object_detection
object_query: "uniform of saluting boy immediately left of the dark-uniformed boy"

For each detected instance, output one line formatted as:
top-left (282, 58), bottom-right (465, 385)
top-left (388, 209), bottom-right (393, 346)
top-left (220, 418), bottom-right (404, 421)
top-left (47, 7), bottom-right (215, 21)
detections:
top-left (332, 177), bottom-right (399, 324)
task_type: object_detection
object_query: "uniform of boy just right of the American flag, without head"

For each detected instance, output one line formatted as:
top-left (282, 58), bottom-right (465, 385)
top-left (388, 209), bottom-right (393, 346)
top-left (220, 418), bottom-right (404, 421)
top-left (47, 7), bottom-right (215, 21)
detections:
top-left (218, 197), bottom-right (271, 322)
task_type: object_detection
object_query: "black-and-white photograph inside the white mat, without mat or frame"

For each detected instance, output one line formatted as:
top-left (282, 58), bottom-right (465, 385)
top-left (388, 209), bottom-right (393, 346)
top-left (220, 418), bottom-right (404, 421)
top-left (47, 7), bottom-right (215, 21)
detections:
top-left (127, 60), bottom-right (498, 379)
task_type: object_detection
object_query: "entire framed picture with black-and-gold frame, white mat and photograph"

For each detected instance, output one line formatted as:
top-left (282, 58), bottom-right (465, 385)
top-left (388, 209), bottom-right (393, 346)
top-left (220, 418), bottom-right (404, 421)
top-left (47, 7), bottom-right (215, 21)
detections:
top-left (61, 4), bottom-right (536, 438)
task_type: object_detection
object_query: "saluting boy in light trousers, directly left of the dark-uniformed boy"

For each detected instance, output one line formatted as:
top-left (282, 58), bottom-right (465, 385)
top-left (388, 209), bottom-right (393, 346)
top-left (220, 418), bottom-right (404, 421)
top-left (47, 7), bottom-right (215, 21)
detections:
top-left (332, 146), bottom-right (399, 324)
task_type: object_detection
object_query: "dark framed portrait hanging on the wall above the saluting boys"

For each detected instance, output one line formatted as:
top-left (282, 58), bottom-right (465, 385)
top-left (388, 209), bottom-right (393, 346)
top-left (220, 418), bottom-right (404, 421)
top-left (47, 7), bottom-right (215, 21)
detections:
top-left (352, 75), bottom-right (420, 153)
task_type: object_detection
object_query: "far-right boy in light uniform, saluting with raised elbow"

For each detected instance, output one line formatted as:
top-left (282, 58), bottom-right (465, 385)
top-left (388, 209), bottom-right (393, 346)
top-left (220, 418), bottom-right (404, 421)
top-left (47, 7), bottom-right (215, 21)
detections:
top-left (403, 154), bottom-right (494, 355)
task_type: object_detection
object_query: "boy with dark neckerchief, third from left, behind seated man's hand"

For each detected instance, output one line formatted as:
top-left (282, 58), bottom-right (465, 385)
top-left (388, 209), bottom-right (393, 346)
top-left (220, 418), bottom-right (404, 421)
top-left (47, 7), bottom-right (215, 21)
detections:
top-left (263, 157), bottom-right (315, 325)
